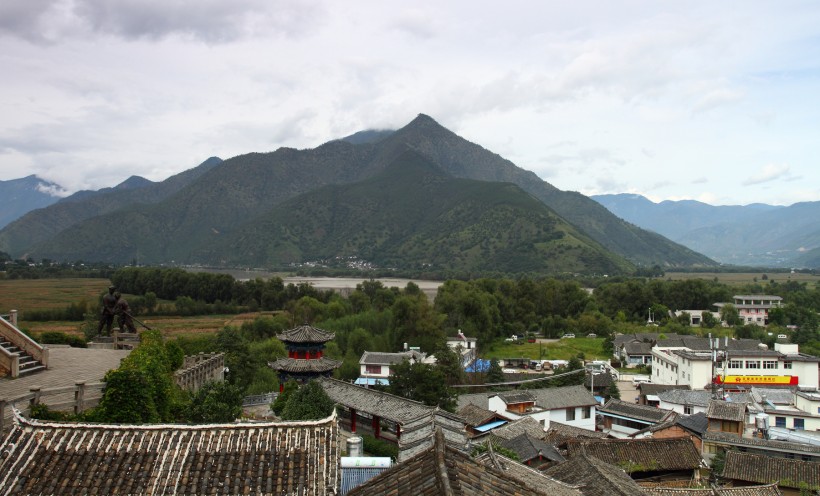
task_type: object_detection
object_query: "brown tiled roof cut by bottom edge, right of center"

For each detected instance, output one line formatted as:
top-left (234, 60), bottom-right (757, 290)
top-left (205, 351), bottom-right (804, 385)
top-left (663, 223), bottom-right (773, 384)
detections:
top-left (544, 454), bottom-right (646, 496)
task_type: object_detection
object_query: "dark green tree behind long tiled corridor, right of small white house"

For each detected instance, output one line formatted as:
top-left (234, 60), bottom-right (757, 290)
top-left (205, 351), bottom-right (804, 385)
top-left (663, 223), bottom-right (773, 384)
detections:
top-left (387, 360), bottom-right (456, 412)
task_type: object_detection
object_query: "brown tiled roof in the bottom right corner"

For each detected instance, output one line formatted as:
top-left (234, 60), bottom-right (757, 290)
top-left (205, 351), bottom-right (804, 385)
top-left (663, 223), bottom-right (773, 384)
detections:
top-left (723, 450), bottom-right (820, 490)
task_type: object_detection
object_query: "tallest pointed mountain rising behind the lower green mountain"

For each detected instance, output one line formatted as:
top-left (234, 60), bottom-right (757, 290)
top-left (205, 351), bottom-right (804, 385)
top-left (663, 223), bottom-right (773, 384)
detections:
top-left (0, 115), bottom-right (714, 274)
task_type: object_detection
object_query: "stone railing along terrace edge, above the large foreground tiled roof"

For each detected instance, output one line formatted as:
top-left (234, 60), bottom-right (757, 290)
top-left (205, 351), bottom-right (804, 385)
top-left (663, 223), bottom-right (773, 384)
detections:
top-left (0, 382), bottom-right (105, 433)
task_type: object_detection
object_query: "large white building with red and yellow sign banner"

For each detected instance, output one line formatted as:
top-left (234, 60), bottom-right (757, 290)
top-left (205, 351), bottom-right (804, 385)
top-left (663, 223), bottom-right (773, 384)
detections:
top-left (652, 341), bottom-right (820, 390)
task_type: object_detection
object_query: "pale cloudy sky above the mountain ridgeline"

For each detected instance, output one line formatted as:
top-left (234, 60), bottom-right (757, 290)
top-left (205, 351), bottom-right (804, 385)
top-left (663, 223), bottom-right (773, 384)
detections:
top-left (0, 0), bottom-right (820, 205)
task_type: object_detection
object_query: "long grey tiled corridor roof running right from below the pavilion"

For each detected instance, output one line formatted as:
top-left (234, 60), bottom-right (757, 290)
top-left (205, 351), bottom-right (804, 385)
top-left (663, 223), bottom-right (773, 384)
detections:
top-left (319, 377), bottom-right (436, 425)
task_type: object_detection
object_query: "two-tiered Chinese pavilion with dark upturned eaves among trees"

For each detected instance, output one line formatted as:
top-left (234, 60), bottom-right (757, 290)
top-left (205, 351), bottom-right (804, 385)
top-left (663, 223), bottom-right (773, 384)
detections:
top-left (268, 324), bottom-right (342, 392)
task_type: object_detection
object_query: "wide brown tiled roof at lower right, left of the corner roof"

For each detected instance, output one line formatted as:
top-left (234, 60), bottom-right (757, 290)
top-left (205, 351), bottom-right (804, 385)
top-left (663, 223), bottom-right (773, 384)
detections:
top-left (567, 437), bottom-right (701, 472)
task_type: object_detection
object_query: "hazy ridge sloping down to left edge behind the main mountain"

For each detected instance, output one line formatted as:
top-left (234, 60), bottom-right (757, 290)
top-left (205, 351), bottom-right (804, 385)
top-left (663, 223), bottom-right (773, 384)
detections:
top-left (0, 157), bottom-right (222, 260)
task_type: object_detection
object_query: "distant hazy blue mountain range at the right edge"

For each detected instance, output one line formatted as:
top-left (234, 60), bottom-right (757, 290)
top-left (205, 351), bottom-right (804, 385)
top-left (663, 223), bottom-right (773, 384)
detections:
top-left (593, 194), bottom-right (820, 268)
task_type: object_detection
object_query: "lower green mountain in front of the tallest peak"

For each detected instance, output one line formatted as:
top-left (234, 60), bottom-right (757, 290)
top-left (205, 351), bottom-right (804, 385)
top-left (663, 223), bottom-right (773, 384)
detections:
top-left (202, 149), bottom-right (631, 274)
